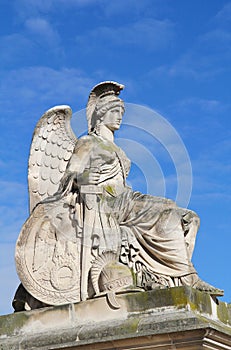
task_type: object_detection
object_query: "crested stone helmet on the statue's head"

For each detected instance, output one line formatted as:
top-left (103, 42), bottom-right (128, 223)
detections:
top-left (87, 81), bottom-right (124, 134)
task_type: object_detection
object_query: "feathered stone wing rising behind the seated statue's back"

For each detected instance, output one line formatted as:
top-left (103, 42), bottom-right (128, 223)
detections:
top-left (28, 106), bottom-right (77, 211)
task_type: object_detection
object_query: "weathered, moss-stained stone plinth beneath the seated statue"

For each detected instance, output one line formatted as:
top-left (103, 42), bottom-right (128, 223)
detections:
top-left (0, 287), bottom-right (231, 350)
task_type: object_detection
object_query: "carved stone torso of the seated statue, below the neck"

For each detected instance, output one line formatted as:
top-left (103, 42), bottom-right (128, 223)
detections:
top-left (67, 135), bottom-right (130, 196)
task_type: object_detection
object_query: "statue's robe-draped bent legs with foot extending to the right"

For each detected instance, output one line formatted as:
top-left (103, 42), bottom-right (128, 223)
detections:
top-left (116, 192), bottom-right (223, 295)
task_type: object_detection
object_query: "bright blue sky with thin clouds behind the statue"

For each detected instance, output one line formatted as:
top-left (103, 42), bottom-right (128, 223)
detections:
top-left (0, 0), bottom-right (231, 314)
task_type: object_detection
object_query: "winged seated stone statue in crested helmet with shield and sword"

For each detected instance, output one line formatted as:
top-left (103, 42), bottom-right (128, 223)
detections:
top-left (13, 81), bottom-right (223, 310)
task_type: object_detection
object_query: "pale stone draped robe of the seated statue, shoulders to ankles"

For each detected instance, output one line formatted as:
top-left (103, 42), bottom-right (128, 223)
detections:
top-left (63, 134), bottom-right (199, 286)
